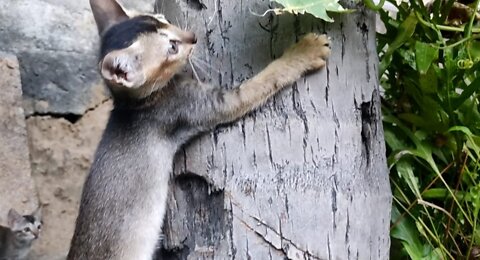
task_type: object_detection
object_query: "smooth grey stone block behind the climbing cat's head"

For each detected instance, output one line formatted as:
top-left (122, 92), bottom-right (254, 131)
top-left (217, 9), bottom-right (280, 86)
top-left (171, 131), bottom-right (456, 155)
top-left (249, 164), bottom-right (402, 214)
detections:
top-left (0, 0), bottom-right (154, 115)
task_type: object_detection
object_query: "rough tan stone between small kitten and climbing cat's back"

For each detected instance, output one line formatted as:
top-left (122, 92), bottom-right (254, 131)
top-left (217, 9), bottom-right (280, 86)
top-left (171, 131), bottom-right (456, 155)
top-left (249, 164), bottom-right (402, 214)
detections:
top-left (27, 101), bottom-right (112, 259)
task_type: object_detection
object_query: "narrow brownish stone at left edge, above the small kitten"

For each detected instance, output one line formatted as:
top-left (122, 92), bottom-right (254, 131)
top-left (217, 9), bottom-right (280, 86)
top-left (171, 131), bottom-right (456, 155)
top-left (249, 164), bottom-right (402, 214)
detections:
top-left (0, 52), bottom-right (38, 225)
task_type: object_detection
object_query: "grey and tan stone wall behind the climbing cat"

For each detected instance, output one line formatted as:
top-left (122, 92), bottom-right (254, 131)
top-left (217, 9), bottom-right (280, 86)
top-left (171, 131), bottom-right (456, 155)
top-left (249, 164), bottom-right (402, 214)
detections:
top-left (0, 0), bottom-right (155, 260)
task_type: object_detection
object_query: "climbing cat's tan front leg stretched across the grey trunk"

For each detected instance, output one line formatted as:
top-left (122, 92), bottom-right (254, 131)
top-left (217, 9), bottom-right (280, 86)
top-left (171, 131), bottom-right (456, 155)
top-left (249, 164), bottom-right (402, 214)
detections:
top-left (197, 33), bottom-right (330, 128)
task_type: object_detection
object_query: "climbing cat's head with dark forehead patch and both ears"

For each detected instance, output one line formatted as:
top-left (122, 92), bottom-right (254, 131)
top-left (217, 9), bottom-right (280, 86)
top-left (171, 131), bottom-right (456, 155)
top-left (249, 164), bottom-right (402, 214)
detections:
top-left (90, 0), bottom-right (196, 98)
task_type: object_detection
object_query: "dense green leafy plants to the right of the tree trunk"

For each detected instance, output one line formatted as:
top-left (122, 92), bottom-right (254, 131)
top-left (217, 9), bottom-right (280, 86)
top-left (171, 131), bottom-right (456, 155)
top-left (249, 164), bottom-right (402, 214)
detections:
top-left (374, 0), bottom-right (480, 259)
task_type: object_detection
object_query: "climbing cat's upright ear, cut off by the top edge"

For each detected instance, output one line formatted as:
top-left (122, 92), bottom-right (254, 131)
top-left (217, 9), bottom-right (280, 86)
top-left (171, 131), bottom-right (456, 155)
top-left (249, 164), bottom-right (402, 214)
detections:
top-left (90, 0), bottom-right (129, 35)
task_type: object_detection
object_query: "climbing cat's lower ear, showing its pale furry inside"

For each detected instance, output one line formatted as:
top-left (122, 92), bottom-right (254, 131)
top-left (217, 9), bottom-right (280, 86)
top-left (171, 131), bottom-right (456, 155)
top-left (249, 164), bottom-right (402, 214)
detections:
top-left (100, 43), bottom-right (146, 88)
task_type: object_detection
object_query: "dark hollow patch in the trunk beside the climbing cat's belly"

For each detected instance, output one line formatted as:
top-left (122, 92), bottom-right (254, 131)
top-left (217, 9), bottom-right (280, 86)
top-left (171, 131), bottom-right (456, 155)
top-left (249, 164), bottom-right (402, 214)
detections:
top-left (155, 173), bottom-right (228, 260)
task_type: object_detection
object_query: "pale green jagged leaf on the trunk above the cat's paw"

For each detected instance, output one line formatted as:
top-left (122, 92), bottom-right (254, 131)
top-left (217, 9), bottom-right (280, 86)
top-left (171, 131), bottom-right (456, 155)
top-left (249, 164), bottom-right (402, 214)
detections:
top-left (272, 0), bottom-right (351, 22)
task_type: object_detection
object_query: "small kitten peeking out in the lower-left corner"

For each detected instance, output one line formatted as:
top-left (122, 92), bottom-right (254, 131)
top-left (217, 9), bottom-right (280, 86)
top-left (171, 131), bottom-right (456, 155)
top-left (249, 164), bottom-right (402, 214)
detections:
top-left (0, 207), bottom-right (43, 260)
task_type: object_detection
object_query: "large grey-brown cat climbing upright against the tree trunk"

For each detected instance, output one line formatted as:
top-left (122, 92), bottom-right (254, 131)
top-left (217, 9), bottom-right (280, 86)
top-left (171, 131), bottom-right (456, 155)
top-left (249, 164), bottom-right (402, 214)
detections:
top-left (67, 0), bottom-right (330, 260)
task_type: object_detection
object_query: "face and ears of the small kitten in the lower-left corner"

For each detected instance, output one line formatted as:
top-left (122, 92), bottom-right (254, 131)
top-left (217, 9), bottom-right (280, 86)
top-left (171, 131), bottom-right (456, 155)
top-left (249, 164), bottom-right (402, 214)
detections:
top-left (8, 207), bottom-right (43, 242)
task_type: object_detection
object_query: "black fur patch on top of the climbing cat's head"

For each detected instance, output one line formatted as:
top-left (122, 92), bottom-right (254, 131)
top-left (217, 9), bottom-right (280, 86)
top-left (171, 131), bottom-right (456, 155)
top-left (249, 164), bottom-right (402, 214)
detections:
top-left (100, 15), bottom-right (167, 59)
